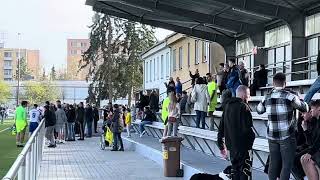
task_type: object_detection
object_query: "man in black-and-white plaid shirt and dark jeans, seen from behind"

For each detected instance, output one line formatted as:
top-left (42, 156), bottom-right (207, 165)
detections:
top-left (257, 73), bottom-right (308, 180)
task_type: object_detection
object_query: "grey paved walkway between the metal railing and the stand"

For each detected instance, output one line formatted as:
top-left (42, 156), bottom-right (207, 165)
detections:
top-left (40, 137), bottom-right (181, 180)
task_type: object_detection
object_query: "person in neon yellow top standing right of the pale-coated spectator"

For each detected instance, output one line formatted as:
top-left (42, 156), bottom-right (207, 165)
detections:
top-left (207, 73), bottom-right (218, 131)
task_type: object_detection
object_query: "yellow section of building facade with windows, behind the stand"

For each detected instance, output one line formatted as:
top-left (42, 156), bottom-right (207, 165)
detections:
top-left (166, 33), bottom-right (225, 90)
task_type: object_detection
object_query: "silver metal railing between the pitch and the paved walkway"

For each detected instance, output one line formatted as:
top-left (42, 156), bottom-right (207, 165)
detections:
top-left (2, 119), bottom-right (45, 180)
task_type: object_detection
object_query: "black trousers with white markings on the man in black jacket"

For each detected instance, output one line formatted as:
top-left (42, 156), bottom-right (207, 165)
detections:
top-left (230, 151), bottom-right (252, 180)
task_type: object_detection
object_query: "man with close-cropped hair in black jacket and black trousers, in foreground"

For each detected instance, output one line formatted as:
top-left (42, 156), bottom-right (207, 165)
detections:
top-left (218, 85), bottom-right (255, 180)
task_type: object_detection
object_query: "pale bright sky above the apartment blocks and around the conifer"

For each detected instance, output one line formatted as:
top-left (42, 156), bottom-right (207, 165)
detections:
top-left (0, 0), bottom-right (172, 70)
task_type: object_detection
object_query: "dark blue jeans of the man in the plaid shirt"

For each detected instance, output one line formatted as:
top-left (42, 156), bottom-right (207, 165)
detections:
top-left (268, 135), bottom-right (297, 180)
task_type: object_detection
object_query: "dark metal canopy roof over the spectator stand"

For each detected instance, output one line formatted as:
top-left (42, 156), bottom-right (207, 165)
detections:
top-left (86, 0), bottom-right (320, 46)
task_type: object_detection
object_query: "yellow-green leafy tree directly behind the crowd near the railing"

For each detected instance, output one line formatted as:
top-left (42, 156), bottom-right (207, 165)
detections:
top-left (22, 81), bottom-right (60, 104)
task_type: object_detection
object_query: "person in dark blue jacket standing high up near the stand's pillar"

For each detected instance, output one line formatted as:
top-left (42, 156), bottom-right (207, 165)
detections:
top-left (226, 59), bottom-right (241, 97)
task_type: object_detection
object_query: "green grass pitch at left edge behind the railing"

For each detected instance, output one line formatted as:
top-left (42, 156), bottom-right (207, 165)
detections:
top-left (0, 120), bottom-right (22, 179)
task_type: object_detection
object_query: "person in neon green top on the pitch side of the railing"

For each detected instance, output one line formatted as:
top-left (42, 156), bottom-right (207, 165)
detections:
top-left (15, 101), bottom-right (28, 147)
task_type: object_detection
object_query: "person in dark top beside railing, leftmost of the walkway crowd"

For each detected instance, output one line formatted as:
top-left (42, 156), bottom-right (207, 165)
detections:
top-left (44, 105), bottom-right (56, 148)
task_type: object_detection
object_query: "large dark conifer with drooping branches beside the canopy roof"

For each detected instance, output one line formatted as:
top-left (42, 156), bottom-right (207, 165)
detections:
top-left (80, 14), bottom-right (156, 102)
